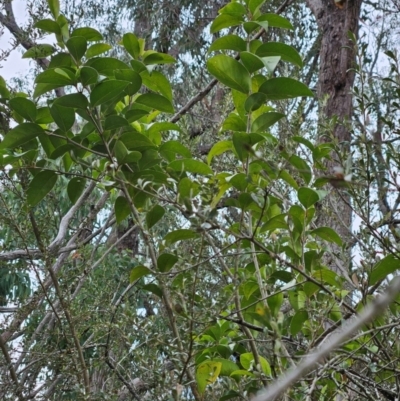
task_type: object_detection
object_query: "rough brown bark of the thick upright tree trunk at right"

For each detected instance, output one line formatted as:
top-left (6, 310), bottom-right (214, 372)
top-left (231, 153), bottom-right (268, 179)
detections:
top-left (307, 0), bottom-right (362, 276)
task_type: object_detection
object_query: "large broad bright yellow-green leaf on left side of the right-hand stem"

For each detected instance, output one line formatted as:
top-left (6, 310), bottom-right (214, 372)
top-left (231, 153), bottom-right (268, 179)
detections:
top-left (207, 55), bottom-right (251, 94)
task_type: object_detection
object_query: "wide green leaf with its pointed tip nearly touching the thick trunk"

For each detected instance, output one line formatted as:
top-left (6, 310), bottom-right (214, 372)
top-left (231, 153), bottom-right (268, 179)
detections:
top-left (259, 77), bottom-right (314, 100)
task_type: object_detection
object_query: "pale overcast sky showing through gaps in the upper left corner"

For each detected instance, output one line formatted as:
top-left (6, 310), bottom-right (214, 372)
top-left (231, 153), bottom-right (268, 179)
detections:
top-left (0, 0), bottom-right (32, 81)
